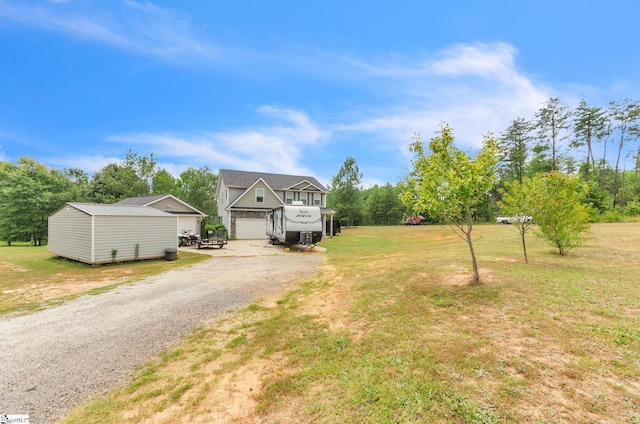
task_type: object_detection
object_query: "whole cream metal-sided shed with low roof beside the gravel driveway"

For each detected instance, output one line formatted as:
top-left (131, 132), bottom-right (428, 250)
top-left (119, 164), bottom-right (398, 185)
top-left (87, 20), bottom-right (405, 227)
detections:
top-left (48, 203), bottom-right (178, 264)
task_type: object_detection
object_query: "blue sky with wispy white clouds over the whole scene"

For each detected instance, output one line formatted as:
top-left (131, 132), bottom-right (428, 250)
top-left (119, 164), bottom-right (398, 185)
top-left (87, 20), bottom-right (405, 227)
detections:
top-left (0, 0), bottom-right (640, 186)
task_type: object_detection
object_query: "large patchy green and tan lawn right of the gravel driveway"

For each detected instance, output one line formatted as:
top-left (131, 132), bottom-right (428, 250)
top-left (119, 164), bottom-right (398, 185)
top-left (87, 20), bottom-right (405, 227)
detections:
top-left (47, 223), bottom-right (640, 423)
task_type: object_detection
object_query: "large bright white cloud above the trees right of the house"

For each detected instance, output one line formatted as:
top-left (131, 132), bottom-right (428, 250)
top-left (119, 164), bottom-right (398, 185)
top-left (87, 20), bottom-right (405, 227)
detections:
top-left (334, 43), bottom-right (549, 151)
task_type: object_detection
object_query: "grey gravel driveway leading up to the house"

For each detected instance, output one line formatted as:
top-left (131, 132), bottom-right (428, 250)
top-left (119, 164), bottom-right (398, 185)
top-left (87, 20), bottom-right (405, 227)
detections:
top-left (0, 241), bottom-right (321, 424)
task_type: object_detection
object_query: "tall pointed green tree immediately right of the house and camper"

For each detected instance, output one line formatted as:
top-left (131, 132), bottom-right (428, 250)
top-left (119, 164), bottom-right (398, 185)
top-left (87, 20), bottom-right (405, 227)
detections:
top-left (327, 157), bottom-right (363, 227)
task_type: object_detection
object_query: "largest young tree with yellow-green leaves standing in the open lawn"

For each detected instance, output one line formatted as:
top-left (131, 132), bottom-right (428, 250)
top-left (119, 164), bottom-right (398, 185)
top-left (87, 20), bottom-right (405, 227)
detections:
top-left (401, 124), bottom-right (498, 284)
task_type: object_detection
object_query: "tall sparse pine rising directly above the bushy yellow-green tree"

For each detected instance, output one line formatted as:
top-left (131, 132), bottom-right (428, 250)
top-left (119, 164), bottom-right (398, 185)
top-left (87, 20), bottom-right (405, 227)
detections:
top-left (534, 97), bottom-right (571, 171)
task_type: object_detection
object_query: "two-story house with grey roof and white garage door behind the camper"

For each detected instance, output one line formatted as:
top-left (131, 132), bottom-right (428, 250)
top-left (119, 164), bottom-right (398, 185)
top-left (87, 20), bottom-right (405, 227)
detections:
top-left (216, 169), bottom-right (334, 240)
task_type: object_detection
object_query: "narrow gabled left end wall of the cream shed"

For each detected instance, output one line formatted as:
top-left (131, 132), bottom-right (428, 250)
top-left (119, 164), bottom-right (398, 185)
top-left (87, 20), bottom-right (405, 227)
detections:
top-left (48, 206), bottom-right (91, 263)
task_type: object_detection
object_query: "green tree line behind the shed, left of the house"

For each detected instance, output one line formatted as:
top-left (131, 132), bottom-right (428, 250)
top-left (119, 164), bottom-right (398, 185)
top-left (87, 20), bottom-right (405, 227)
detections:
top-left (0, 149), bottom-right (218, 246)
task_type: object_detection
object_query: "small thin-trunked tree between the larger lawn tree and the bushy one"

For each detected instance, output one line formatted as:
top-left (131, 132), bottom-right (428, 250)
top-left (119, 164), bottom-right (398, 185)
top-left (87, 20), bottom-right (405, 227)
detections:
top-left (499, 177), bottom-right (535, 264)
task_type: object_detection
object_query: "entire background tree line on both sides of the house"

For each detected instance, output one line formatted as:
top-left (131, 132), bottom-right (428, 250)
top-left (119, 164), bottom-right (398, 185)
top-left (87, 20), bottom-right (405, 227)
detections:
top-left (0, 97), bottom-right (640, 245)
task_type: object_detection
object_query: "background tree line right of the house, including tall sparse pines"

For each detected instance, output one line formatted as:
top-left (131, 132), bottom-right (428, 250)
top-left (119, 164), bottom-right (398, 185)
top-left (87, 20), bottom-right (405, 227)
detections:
top-left (328, 97), bottom-right (640, 229)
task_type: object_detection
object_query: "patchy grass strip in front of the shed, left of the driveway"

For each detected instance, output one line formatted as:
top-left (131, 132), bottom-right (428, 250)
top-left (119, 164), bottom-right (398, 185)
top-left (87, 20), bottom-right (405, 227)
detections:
top-left (0, 243), bottom-right (208, 316)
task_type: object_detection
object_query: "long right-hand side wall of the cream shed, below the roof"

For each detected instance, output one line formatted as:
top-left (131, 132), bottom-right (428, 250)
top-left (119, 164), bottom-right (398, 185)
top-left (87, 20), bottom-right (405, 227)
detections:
top-left (94, 216), bottom-right (178, 263)
